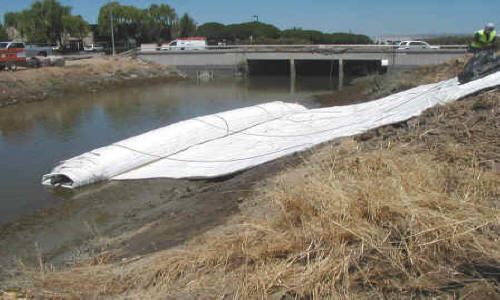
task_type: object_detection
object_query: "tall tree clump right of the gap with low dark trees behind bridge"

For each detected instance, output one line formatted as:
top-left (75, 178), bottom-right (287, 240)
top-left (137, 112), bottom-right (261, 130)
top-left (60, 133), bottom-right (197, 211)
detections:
top-left (98, 2), bottom-right (372, 44)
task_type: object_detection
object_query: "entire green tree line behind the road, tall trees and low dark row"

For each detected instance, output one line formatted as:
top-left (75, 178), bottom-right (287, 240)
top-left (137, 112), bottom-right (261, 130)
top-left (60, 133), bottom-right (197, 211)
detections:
top-left (0, 0), bottom-right (372, 46)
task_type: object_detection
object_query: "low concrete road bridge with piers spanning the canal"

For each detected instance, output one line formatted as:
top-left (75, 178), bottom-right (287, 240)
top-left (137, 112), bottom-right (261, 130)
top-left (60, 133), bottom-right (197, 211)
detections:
top-left (138, 45), bottom-right (466, 85)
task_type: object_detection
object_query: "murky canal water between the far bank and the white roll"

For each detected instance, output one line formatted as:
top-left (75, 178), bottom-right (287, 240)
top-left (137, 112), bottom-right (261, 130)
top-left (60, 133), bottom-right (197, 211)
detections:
top-left (0, 77), bottom-right (337, 225)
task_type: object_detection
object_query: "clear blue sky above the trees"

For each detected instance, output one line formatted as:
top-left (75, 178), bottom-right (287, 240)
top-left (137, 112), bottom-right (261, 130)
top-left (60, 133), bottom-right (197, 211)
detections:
top-left (0, 0), bottom-right (500, 37)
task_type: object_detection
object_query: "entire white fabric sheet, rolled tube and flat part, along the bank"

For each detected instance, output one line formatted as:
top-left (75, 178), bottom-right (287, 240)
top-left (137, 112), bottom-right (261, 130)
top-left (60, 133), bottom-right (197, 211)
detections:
top-left (42, 72), bottom-right (500, 188)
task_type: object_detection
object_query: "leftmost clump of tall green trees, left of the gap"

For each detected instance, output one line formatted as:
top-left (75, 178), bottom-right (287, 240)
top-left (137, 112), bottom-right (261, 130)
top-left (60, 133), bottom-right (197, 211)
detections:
top-left (4, 0), bottom-right (89, 45)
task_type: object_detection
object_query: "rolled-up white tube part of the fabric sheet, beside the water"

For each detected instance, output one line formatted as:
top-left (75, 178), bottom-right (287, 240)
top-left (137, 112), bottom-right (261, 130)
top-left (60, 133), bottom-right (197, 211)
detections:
top-left (42, 102), bottom-right (306, 188)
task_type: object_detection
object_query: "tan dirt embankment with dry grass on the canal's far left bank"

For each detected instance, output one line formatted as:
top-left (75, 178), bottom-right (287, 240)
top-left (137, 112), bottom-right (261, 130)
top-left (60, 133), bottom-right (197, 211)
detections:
top-left (0, 57), bottom-right (181, 108)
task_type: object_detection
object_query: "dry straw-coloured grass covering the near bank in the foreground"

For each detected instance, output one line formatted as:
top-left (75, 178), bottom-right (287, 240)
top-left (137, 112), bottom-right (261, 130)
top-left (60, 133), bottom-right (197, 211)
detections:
top-left (17, 91), bottom-right (500, 299)
